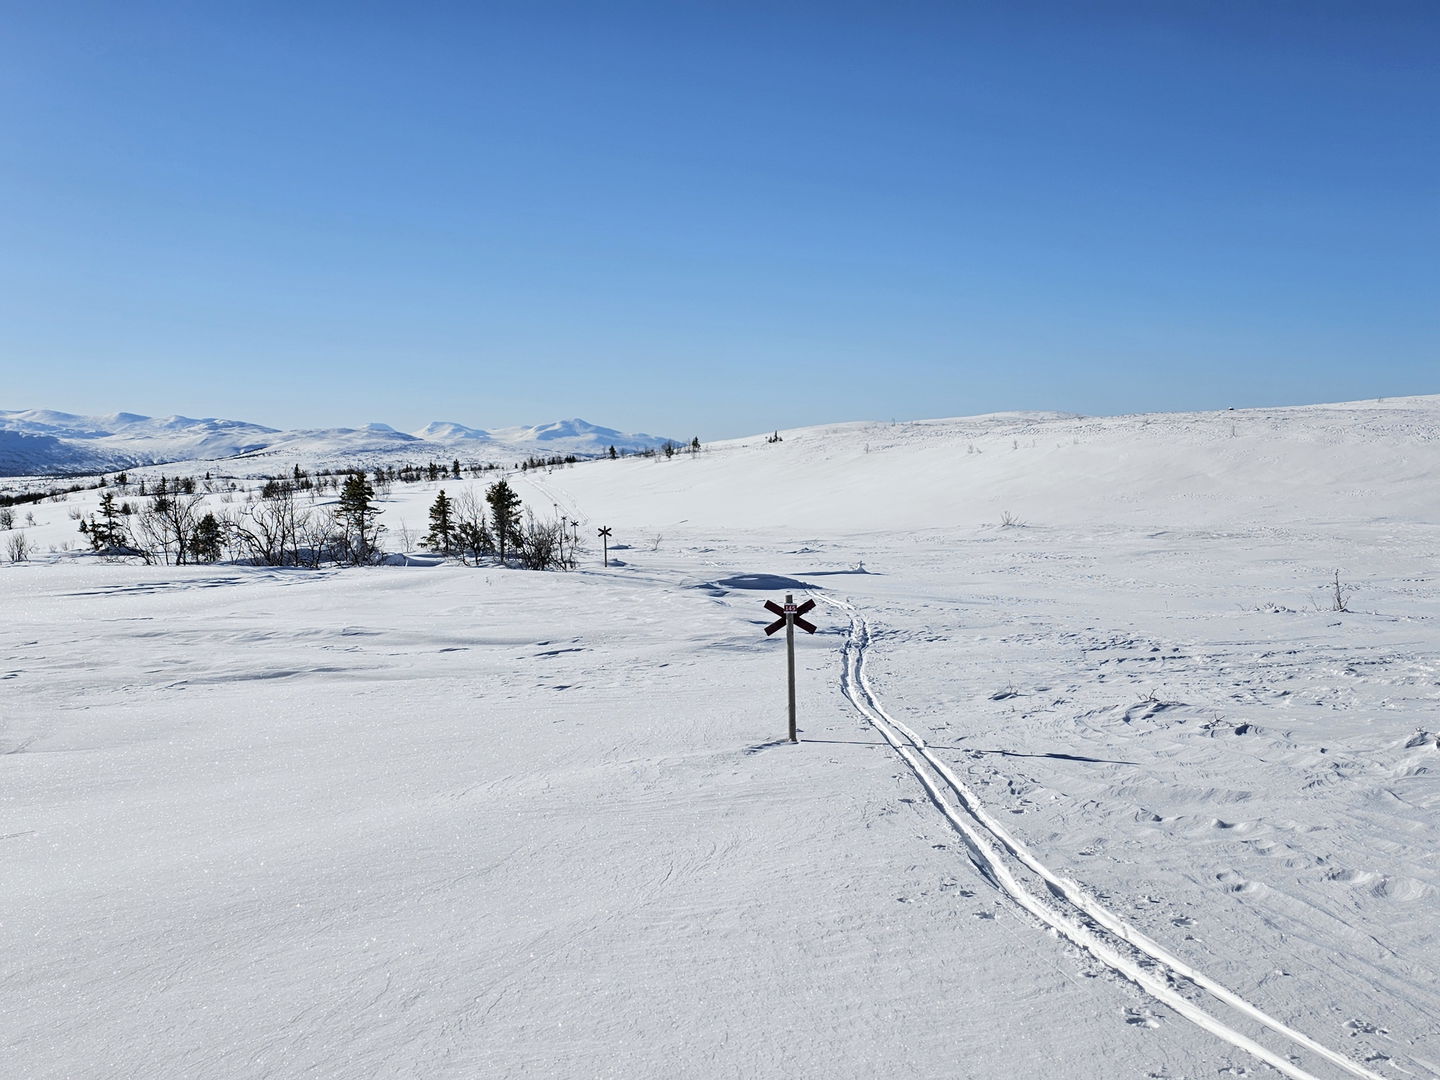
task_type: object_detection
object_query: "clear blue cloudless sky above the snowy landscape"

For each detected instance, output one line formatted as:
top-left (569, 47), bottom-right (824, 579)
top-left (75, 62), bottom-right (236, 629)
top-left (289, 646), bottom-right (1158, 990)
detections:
top-left (0, 0), bottom-right (1440, 438)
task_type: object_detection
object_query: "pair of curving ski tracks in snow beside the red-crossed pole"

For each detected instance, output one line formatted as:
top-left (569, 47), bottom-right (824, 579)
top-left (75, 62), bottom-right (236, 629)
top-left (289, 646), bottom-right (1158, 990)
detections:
top-left (815, 593), bottom-right (1385, 1080)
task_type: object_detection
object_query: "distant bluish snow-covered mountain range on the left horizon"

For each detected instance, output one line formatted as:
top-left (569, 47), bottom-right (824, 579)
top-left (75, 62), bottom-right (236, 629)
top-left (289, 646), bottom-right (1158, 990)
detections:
top-left (0, 409), bottom-right (667, 477)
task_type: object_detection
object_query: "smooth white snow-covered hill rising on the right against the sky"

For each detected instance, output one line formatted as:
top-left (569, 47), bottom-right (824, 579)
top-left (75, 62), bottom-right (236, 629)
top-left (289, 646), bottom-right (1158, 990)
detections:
top-left (518, 396), bottom-right (1440, 536)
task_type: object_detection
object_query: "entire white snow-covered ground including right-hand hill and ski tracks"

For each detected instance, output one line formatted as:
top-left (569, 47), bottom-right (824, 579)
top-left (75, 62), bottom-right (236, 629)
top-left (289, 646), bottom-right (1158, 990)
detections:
top-left (0, 397), bottom-right (1440, 1080)
